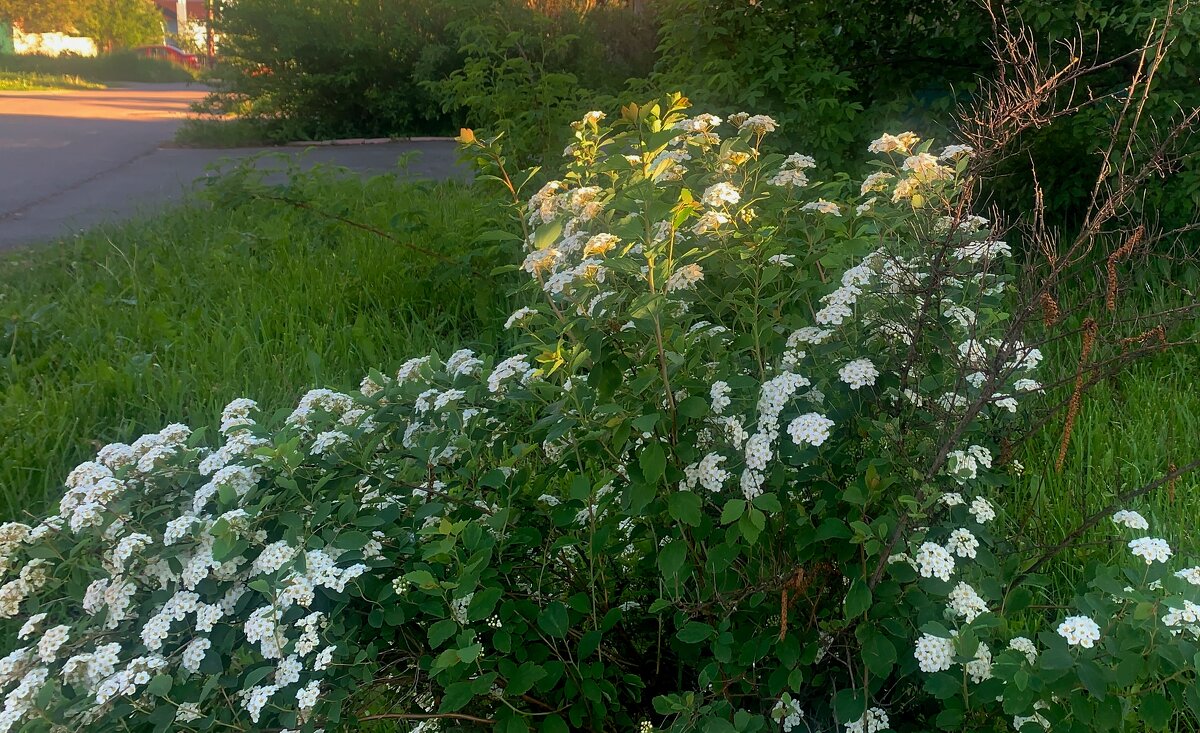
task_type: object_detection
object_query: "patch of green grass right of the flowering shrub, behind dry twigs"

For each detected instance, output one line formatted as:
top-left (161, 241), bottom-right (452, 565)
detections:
top-left (1008, 263), bottom-right (1200, 578)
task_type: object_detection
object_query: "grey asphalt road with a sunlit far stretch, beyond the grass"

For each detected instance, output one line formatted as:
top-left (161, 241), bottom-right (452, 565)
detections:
top-left (0, 84), bottom-right (456, 250)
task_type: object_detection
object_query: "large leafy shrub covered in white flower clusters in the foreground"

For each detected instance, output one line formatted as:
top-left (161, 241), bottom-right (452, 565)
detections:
top-left (0, 97), bottom-right (1200, 733)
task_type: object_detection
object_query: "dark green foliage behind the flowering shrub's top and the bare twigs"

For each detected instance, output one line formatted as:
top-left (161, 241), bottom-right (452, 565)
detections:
top-left (650, 0), bottom-right (1200, 232)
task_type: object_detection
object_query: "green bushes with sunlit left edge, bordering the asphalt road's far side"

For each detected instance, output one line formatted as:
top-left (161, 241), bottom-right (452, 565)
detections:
top-left (199, 0), bottom-right (654, 149)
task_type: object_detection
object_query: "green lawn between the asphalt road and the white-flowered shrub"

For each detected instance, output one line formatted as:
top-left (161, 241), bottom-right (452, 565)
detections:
top-left (0, 169), bottom-right (509, 518)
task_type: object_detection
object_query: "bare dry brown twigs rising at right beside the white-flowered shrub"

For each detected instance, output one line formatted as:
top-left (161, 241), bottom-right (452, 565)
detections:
top-left (870, 0), bottom-right (1200, 587)
